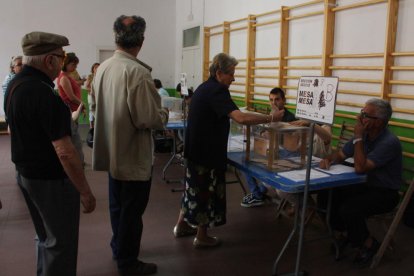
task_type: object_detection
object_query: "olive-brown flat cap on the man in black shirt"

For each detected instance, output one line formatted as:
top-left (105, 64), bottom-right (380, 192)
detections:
top-left (22, 32), bottom-right (69, 56)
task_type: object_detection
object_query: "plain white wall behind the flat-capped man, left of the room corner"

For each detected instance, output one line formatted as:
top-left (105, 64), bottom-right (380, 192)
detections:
top-left (0, 0), bottom-right (175, 115)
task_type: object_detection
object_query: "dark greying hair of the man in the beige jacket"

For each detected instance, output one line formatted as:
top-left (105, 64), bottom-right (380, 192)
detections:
top-left (114, 15), bottom-right (146, 49)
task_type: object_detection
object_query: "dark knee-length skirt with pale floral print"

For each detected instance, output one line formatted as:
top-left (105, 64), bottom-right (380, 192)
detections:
top-left (181, 161), bottom-right (226, 227)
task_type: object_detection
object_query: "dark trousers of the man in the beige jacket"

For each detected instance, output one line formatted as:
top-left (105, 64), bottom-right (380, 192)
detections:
top-left (108, 173), bottom-right (151, 268)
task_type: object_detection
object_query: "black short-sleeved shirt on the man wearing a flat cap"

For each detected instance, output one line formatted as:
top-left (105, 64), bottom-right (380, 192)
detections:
top-left (7, 66), bottom-right (71, 179)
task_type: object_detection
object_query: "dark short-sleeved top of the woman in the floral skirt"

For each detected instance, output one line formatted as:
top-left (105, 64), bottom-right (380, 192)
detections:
top-left (184, 78), bottom-right (238, 169)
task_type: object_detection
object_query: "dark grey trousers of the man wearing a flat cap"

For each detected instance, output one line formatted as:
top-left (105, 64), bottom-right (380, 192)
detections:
top-left (17, 173), bottom-right (80, 276)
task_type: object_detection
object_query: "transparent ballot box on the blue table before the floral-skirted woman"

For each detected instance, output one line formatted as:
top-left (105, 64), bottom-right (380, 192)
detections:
top-left (246, 122), bottom-right (310, 171)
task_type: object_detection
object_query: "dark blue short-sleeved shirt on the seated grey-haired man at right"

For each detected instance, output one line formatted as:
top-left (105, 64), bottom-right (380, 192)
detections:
top-left (342, 129), bottom-right (402, 190)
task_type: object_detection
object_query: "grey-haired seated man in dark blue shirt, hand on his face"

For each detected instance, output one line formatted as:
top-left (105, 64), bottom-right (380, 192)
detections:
top-left (318, 98), bottom-right (402, 267)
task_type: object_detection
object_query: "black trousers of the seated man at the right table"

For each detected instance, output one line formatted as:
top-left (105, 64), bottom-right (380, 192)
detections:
top-left (318, 184), bottom-right (399, 247)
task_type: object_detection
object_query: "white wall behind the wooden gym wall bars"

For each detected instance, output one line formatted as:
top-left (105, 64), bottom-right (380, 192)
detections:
top-left (175, 0), bottom-right (414, 120)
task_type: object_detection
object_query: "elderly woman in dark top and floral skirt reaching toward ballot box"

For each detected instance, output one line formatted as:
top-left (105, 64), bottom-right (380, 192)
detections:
top-left (173, 53), bottom-right (284, 248)
